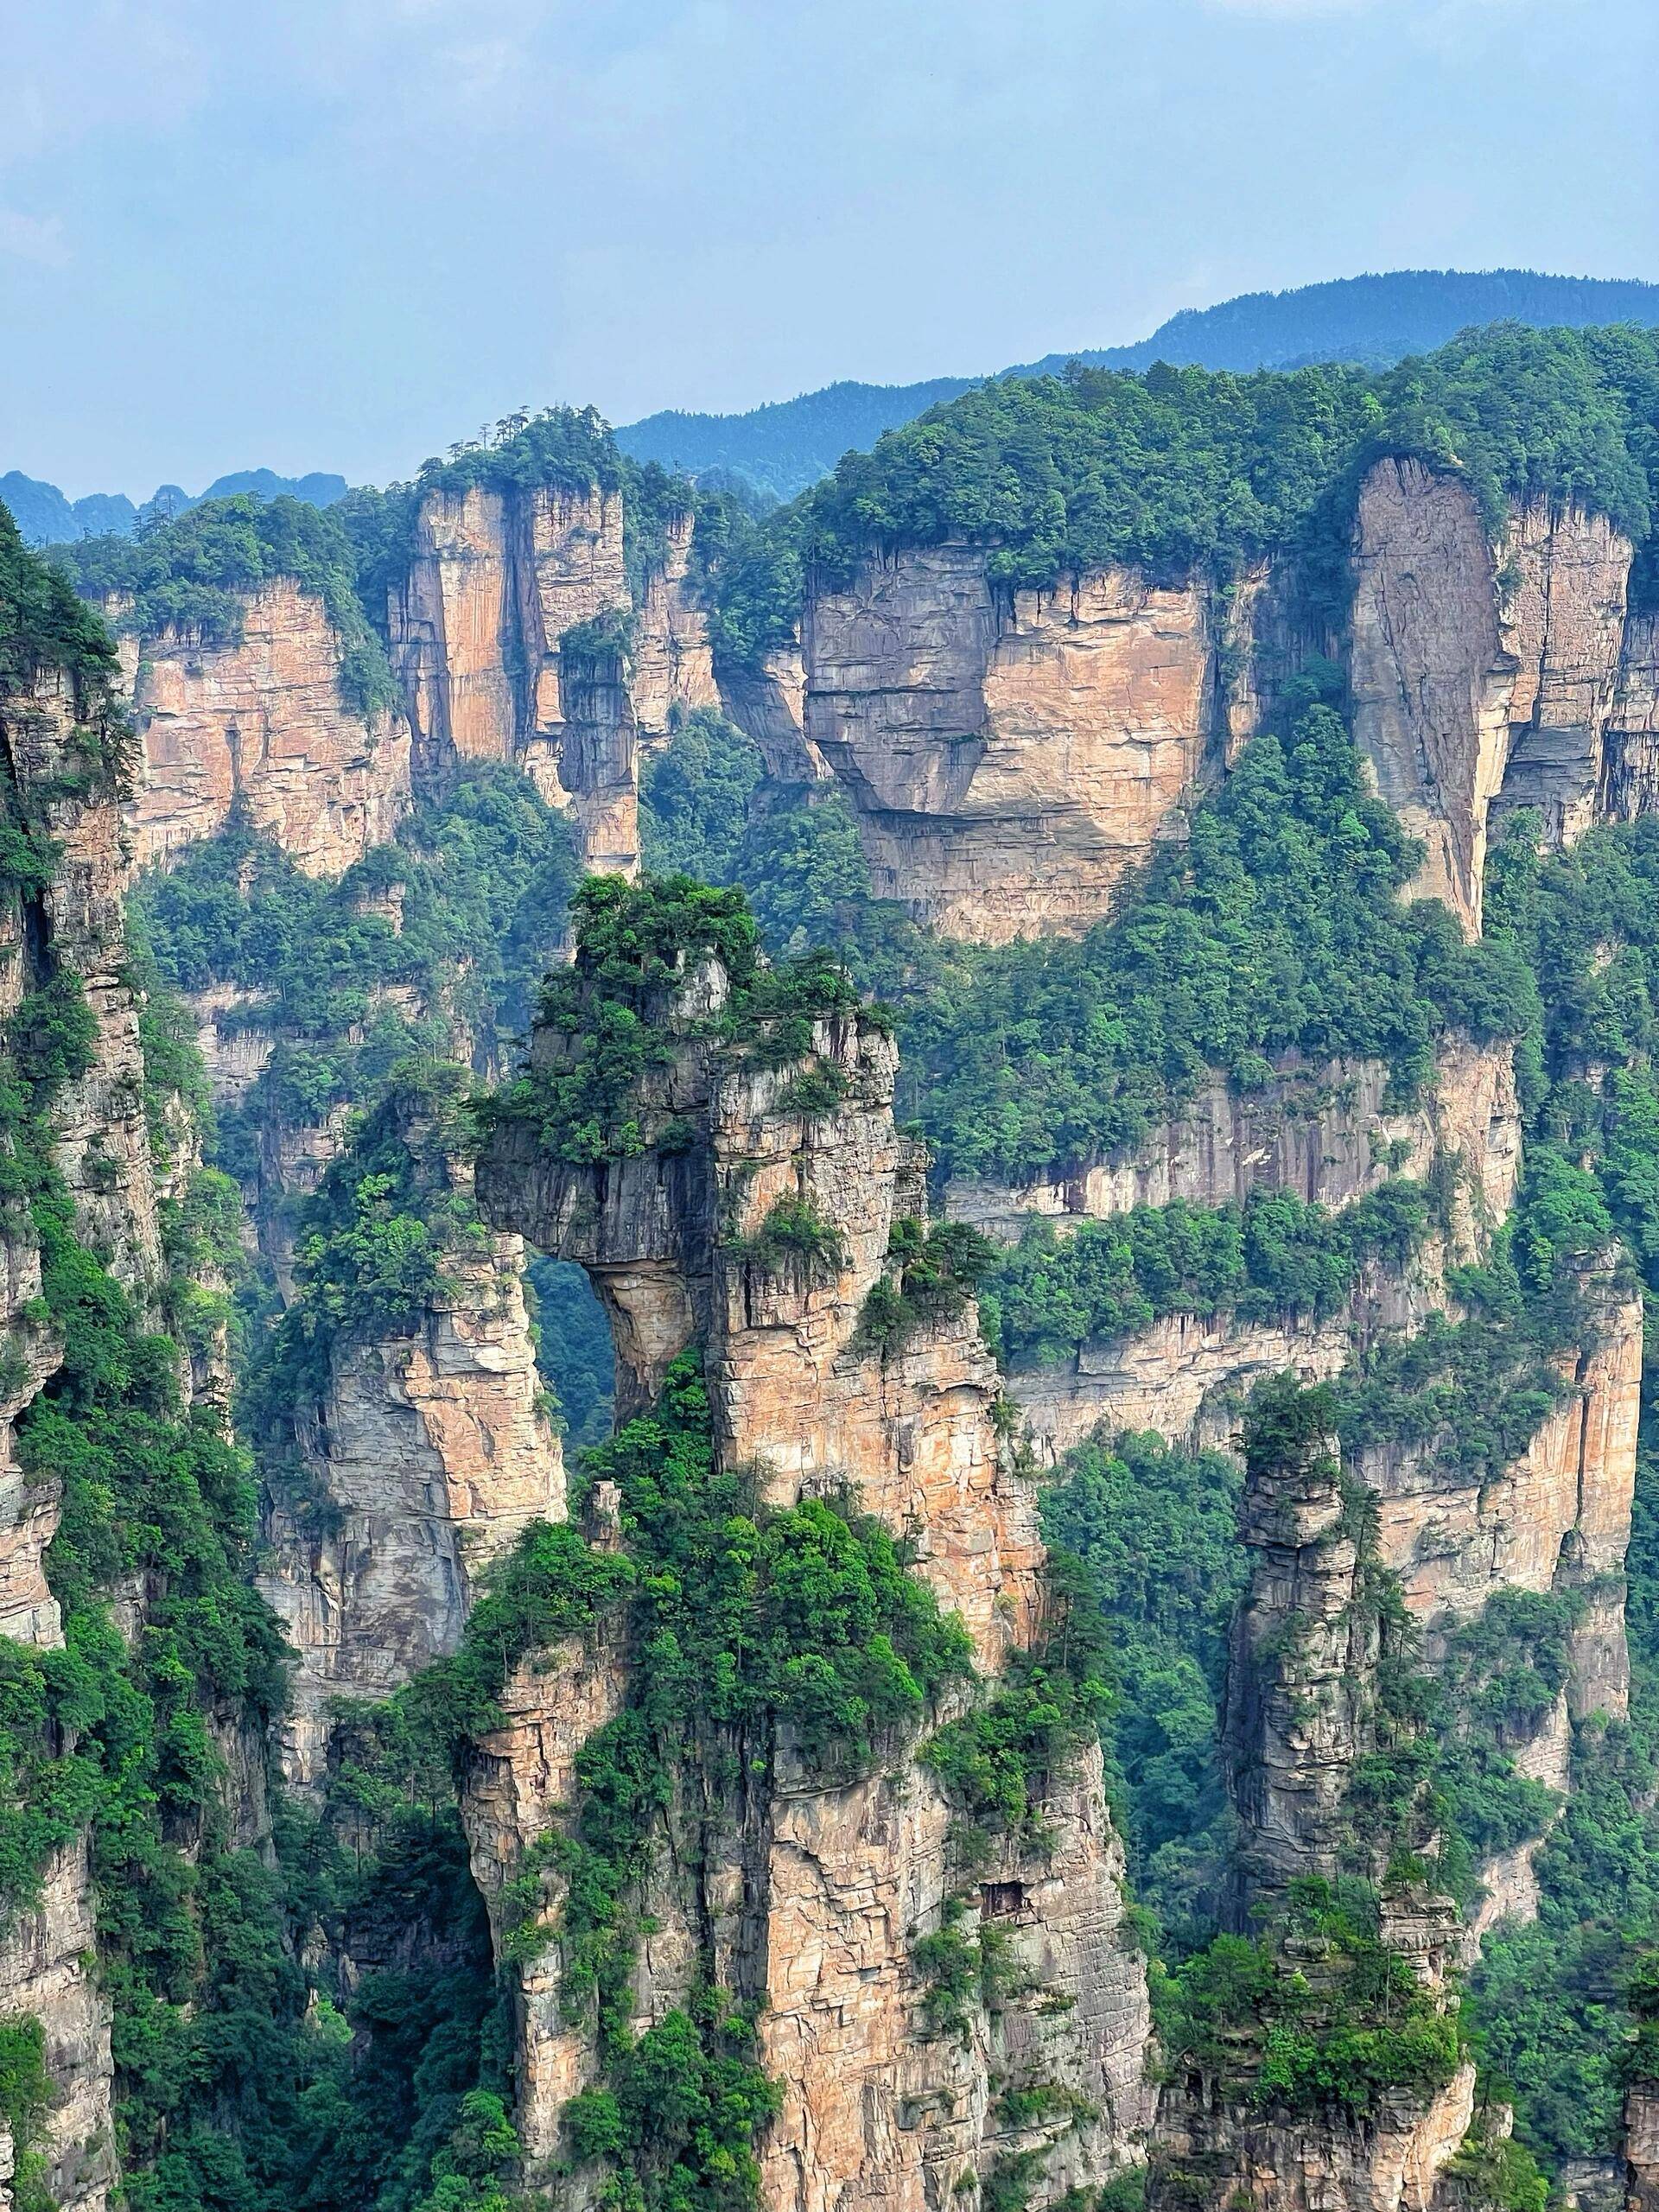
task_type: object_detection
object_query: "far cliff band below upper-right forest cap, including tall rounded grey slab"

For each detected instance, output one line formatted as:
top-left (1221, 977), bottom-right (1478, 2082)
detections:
top-left (796, 460), bottom-right (1655, 943)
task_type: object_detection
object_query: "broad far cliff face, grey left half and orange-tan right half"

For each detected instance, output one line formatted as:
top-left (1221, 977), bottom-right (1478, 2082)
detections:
top-left (803, 544), bottom-right (1217, 943)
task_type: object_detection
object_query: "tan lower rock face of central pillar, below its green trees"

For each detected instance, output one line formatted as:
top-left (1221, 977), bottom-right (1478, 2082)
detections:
top-left (761, 1752), bottom-right (1150, 2212)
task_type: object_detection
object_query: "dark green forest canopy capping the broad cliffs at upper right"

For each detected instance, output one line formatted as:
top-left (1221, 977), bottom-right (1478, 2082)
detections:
top-left (716, 323), bottom-right (1659, 657)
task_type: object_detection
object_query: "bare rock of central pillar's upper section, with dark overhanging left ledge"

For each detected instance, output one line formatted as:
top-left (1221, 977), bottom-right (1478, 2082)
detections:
top-left (478, 969), bottom-right (1039, 1666)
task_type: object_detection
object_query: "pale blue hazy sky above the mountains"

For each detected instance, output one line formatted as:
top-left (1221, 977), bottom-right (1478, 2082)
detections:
top-left (0, 0), bottom-right (1659, 495)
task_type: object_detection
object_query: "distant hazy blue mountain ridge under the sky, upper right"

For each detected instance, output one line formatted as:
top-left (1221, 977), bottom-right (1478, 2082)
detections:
top-left (617, 270), bottom-right (1659, 500)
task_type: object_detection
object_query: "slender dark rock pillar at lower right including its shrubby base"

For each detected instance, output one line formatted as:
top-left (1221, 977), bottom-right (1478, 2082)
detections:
top-left (1150, 1378), bottom-right (1476, 2212)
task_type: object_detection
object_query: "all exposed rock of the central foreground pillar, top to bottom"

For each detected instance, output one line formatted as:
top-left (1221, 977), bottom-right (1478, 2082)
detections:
top-left (467, 933), bottom-right (1150, 2212)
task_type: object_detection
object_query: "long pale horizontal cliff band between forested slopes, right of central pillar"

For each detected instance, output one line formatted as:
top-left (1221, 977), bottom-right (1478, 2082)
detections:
top-left (944, 1038), bottom-right (1520, 1256)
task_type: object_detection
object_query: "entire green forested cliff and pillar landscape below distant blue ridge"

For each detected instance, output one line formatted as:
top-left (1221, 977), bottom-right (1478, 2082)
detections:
top-left (0, 325), bottom-right (1659, 2212)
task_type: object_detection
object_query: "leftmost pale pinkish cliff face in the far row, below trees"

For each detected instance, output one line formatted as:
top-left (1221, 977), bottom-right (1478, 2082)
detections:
top-left (109, 577), bottom-right (410, 876)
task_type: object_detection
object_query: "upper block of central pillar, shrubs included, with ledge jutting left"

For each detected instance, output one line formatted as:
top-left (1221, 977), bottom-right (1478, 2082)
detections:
top-left (478, 898), bottom-right (1042, 1666)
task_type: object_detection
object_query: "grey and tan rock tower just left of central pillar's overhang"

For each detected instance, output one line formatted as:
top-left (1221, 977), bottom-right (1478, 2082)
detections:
top-left (259, 1093), bottom-right (564, 1789)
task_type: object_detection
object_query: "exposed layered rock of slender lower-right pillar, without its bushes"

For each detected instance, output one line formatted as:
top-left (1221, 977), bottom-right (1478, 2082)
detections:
top-left (1148, 1394), bottom-right (1476, 2212)
